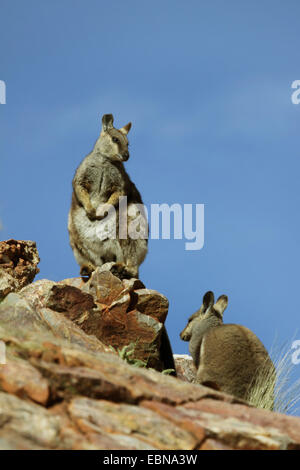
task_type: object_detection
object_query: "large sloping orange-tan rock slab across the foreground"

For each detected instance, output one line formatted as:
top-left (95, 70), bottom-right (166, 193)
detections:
top-left (0, 283), bottom-right (300, 450)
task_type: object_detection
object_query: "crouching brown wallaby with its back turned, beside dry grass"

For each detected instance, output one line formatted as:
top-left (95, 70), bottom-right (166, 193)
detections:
top-left (180, 292), bottom-right (274, 409)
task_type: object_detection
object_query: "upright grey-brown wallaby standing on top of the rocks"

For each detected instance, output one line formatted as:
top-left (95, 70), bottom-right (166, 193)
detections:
top-left (68, 114), bottom-right (148, 277)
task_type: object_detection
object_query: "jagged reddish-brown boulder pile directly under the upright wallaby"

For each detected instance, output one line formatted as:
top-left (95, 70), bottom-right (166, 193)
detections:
top-left (54, 263), bottom-right (175, 371)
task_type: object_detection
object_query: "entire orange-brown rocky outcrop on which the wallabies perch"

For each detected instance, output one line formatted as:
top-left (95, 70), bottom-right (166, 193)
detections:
top-left (0, 240), bottom-right (300, 450)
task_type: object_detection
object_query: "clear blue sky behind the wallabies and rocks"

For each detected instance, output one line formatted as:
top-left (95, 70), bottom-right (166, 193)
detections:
top-left (0, 0), bottom-right (300, 412)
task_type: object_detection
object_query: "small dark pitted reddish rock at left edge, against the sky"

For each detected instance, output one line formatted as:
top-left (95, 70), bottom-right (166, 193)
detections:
top-left (0, 240), bottom-right (40, 300)
